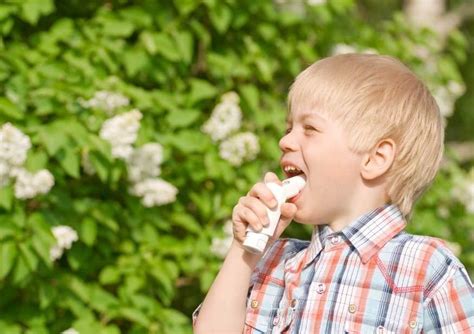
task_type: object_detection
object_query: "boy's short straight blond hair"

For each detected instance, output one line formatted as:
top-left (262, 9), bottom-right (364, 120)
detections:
top-left (288, 54), bottom-right (445, 219)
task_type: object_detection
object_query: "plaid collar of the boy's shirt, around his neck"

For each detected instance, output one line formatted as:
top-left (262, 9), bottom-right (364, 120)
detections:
top-left (303, 203), bottom-right (406, 267)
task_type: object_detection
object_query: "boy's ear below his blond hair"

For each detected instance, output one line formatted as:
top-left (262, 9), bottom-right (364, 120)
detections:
top-left (360, 138), bottom-right (396, 180)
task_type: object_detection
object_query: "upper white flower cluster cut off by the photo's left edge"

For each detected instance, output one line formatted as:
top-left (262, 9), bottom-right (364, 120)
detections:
top-left (0, 123), bottom-right (31, 170)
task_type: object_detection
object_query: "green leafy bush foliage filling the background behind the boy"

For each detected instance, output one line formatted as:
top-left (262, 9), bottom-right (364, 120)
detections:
top-left (0, 0), bottom-right (474, 333)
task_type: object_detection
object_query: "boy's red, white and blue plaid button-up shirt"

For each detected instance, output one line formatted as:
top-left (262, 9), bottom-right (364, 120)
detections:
top-left (193, 204), bottom-right (474, 334)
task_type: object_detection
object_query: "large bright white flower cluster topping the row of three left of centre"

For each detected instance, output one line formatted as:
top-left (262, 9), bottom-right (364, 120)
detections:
top-left (99, 109), bottom-right (142, 160)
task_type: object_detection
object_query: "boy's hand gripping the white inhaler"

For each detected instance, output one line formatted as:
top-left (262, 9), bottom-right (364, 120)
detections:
top-left (232, 172), bottom-right (297, 252)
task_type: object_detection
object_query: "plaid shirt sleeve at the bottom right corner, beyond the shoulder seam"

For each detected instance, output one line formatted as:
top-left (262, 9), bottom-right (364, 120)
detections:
top-left (423, 267), bottom-right (474, 334)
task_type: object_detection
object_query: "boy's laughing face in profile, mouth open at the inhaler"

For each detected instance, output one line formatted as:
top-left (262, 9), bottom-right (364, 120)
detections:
top-left (279, 105), bottom-right (362, 224)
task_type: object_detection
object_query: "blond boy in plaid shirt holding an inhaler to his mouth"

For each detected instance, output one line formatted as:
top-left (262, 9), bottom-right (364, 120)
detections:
top-left (193, 54), bottom-right (474, 334)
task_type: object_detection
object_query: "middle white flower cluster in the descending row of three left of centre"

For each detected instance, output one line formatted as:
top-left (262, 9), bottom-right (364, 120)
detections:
top-left (127, 143), bottom-right (163, 182)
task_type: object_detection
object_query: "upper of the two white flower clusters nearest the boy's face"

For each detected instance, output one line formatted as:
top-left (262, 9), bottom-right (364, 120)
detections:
top-left (201, 92), bottom-right (242, 142)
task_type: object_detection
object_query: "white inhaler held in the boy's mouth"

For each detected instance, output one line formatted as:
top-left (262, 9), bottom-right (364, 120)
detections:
top-left (243, 175), bottom-right (306, 254)
